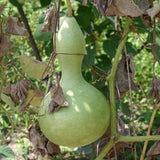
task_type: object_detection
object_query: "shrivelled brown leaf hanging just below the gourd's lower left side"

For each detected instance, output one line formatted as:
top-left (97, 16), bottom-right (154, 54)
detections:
top-left (29, 125), bottom-right (47, 156)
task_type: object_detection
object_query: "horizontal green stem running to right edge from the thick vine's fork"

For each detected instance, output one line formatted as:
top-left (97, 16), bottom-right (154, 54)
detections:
top-left (118, 135), bottom-right (160, 142)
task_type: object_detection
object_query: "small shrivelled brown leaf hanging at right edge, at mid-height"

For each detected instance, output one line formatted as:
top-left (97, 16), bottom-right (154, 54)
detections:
top-left (148, 77), bottom-right (160, 104)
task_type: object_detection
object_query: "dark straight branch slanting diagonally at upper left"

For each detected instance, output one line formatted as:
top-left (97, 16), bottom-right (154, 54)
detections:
top-left (17, 7), bottom-right (41, 61)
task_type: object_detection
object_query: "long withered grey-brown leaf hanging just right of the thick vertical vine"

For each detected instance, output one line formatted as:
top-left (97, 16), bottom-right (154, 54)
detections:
top-left (115, 54), bottom-right (137, 99)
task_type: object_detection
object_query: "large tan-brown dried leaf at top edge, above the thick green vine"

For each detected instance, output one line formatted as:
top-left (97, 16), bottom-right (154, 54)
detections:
top-left (92, 0), bottom-right (143, 17)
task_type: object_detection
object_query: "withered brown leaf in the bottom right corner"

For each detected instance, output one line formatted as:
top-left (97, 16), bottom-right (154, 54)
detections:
top-left (147, 141), bottom-right (160, 158)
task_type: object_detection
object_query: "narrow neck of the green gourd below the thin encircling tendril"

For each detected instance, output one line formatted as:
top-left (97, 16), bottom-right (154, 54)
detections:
top-left (58, 55), bottom-right (83, 83)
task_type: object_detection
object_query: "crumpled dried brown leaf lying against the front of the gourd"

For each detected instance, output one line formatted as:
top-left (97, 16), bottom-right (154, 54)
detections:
top-left (48, 74), bottom-right (68, 114)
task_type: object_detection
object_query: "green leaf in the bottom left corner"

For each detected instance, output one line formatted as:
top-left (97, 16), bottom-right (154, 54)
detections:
top-left (0, 145), bottom-right (15, 159)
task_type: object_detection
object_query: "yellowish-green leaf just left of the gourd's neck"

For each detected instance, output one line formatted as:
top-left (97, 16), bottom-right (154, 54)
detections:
top-left (20, 54), bottom-right (50, 79)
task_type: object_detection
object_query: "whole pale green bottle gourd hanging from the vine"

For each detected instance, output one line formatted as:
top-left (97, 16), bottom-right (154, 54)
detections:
top-left (39, 17), bottom-right (110, 147)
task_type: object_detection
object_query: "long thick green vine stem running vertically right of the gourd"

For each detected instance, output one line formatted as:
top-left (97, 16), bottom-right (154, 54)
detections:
top-left (96, 17), bottom-right (132, 160)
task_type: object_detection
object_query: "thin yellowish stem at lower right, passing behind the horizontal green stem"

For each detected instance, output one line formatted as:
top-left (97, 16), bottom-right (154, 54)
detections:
top-left (140, 103), bottom-right (160, 160)
